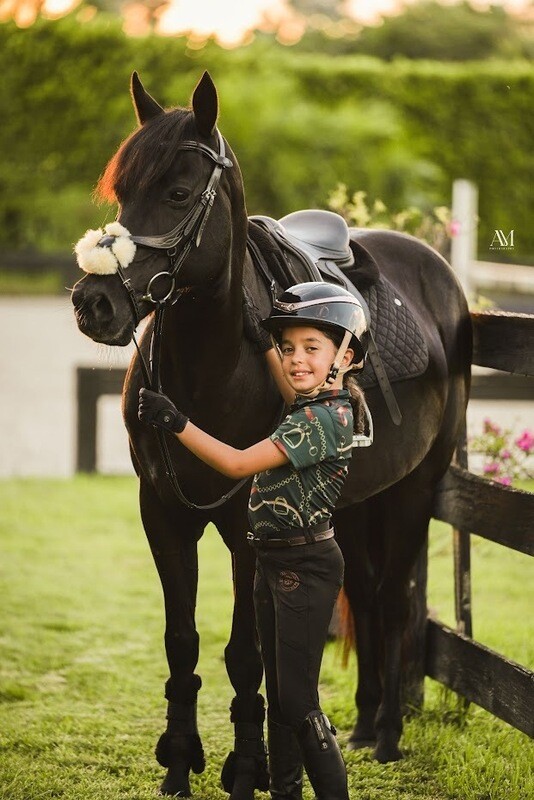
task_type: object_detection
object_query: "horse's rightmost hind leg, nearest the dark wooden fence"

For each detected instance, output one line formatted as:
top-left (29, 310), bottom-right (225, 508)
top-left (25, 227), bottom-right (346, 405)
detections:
top-left (374, 476), bottom-right (432, 763)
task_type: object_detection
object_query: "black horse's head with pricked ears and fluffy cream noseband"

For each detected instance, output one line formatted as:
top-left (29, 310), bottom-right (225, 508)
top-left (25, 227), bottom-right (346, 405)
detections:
top-left (72, 73), bottom-right (246, 345)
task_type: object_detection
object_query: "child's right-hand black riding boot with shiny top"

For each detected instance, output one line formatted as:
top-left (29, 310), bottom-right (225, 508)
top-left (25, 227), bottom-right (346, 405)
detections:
top-left (298, 711), bottom-right (349, 800)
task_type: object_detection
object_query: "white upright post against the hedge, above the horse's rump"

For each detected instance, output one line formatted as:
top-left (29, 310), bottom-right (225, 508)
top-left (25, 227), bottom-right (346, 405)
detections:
top-left (451, 179), bottom-right (478, 296)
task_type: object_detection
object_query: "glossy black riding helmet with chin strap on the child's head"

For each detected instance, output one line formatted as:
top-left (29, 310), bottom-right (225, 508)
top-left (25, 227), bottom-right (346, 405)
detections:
top-left (262, 281), bottom-right (370, 366)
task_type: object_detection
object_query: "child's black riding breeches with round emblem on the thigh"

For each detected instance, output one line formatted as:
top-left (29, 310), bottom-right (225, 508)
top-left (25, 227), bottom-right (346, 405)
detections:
top-left (254, 539), bottom-right (344, 730)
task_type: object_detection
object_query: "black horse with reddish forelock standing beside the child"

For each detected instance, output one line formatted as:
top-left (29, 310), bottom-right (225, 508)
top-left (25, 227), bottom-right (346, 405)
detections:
top-left (72, 73), bottom-right (471, 800)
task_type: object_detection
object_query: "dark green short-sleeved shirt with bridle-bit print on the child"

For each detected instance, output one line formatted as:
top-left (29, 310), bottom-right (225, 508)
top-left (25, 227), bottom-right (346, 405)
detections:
top-left (249, 389), bottom-right (353, 536)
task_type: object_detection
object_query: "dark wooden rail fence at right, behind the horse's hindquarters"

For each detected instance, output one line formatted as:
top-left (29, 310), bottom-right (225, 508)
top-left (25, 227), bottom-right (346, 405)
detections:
top-left (432, 312), bottom-right (534, 737)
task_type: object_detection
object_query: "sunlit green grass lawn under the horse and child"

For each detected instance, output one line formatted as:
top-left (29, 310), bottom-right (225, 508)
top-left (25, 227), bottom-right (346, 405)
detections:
top-left (0, 476), bottom-right (534, 800)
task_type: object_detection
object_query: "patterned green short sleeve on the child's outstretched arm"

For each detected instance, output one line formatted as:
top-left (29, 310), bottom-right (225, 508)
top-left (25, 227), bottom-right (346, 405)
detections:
top-left (270, 405), bottom-right (338, 469)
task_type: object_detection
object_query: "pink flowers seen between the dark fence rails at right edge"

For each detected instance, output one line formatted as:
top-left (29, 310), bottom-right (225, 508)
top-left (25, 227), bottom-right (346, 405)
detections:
top-left (469, 418), bottom-right (534, 486)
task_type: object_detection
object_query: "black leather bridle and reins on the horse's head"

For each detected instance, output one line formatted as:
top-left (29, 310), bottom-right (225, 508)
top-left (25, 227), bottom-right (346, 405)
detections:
top-left (109, 131), bottom-right (253, 511)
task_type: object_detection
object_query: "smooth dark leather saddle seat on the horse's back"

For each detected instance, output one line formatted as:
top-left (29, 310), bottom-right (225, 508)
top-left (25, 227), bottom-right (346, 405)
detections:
top-left (249, 209), bottom-right (354, 281)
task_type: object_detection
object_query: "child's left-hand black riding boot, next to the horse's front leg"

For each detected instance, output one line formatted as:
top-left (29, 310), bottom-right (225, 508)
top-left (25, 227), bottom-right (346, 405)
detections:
top-left (267, 716), bottom-right (302, 800)
